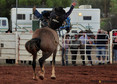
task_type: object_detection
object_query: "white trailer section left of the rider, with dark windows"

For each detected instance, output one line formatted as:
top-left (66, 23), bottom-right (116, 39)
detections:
top-left (11, 8), bottom-right (52, 31)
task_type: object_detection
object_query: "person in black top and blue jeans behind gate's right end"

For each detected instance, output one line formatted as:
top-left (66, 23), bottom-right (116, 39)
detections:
top-left (96, 30), bottom-right (107, 65)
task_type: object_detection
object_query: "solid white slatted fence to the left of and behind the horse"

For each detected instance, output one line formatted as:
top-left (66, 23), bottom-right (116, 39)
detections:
top-left (0, 32), bottom-right (61, 63)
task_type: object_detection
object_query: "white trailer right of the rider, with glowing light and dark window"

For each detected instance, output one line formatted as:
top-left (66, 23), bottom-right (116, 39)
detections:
top-left (67, 5), bottom-right (100, 32)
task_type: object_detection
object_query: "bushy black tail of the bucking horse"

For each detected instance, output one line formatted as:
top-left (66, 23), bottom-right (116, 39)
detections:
top-left (25, 38), bottom-right (41, 55)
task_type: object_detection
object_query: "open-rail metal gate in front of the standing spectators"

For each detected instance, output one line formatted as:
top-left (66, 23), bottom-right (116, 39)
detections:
top-left (64, 33), bottom-right (110, 64)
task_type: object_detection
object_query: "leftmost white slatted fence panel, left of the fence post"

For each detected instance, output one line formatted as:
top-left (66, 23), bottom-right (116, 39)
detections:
top-left (0, 33), bottom-right (16, 59)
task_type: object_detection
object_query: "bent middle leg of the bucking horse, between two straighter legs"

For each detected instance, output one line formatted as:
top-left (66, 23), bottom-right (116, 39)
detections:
top-left (39, 52), bottom-right (52, 80)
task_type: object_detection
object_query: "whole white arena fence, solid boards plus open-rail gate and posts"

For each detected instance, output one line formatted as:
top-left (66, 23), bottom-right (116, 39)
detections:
top-left (0, 30), bottom-right (117, 63)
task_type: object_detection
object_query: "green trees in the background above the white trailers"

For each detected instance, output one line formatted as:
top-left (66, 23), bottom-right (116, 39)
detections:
top-left (0, 0), bottom-right (117, 29)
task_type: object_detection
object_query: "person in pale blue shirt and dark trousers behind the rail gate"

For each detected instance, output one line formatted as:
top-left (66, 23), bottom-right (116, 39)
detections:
top-left (79, 32), bottom-right (87, 66)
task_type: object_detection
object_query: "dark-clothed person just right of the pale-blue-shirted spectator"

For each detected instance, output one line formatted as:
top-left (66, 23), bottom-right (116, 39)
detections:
top-left (86, 36), bottom-right (93, 66)
